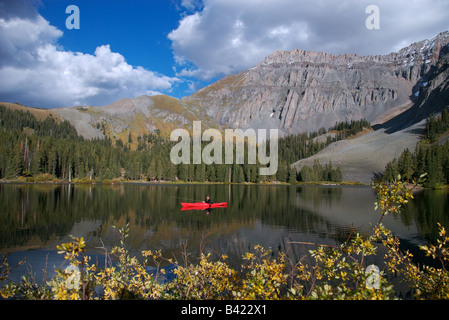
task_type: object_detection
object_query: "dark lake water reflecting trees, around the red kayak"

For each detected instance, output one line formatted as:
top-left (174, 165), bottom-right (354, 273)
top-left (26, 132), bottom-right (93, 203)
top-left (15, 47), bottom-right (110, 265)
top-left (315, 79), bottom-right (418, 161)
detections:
top-left (0, 184), bottom-right (449, 280)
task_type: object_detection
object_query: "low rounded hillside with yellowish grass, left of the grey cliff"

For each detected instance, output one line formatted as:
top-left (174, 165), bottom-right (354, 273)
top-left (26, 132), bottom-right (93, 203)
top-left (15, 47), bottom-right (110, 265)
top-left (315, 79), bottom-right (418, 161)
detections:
top-left (53, 95), bottom-right (216, 148)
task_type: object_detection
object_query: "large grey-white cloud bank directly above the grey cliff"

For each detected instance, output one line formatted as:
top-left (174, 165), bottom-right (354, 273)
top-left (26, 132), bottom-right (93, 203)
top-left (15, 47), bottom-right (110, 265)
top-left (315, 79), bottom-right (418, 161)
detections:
top-left (168, 0), bottom-right (449, 80)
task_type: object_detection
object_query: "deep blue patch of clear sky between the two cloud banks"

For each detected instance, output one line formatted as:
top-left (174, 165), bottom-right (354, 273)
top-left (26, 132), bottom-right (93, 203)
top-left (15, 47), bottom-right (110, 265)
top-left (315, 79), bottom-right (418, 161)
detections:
top-left (37, 0), bottom-right (203, 98)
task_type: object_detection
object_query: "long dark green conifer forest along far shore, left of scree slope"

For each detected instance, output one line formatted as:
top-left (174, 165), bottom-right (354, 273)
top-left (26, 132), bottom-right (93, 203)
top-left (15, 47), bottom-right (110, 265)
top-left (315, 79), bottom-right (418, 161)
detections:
top-left (0, 106), bottom-right (370, 183)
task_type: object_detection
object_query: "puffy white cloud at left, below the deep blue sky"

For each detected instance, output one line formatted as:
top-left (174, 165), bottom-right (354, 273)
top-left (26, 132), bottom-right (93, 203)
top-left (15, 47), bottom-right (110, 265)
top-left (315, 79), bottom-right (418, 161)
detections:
top-left (0, 5), bottom-right (178, 107)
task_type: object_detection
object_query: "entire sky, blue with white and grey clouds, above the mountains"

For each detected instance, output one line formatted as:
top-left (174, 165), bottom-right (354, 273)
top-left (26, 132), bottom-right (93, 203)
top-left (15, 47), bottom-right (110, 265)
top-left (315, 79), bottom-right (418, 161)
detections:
top-left (0, 0), bottom-right (449, 108)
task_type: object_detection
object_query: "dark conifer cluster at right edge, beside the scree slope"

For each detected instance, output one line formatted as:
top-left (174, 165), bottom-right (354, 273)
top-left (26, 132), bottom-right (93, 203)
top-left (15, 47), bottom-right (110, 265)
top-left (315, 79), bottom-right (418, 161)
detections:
top-left (383, 109), bottom-right (449, 188)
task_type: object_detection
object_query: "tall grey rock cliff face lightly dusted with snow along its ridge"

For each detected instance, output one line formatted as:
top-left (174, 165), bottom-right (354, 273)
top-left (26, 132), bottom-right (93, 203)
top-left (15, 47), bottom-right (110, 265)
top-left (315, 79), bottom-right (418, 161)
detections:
top-left (183, 32), bottom-right (449, 134)
